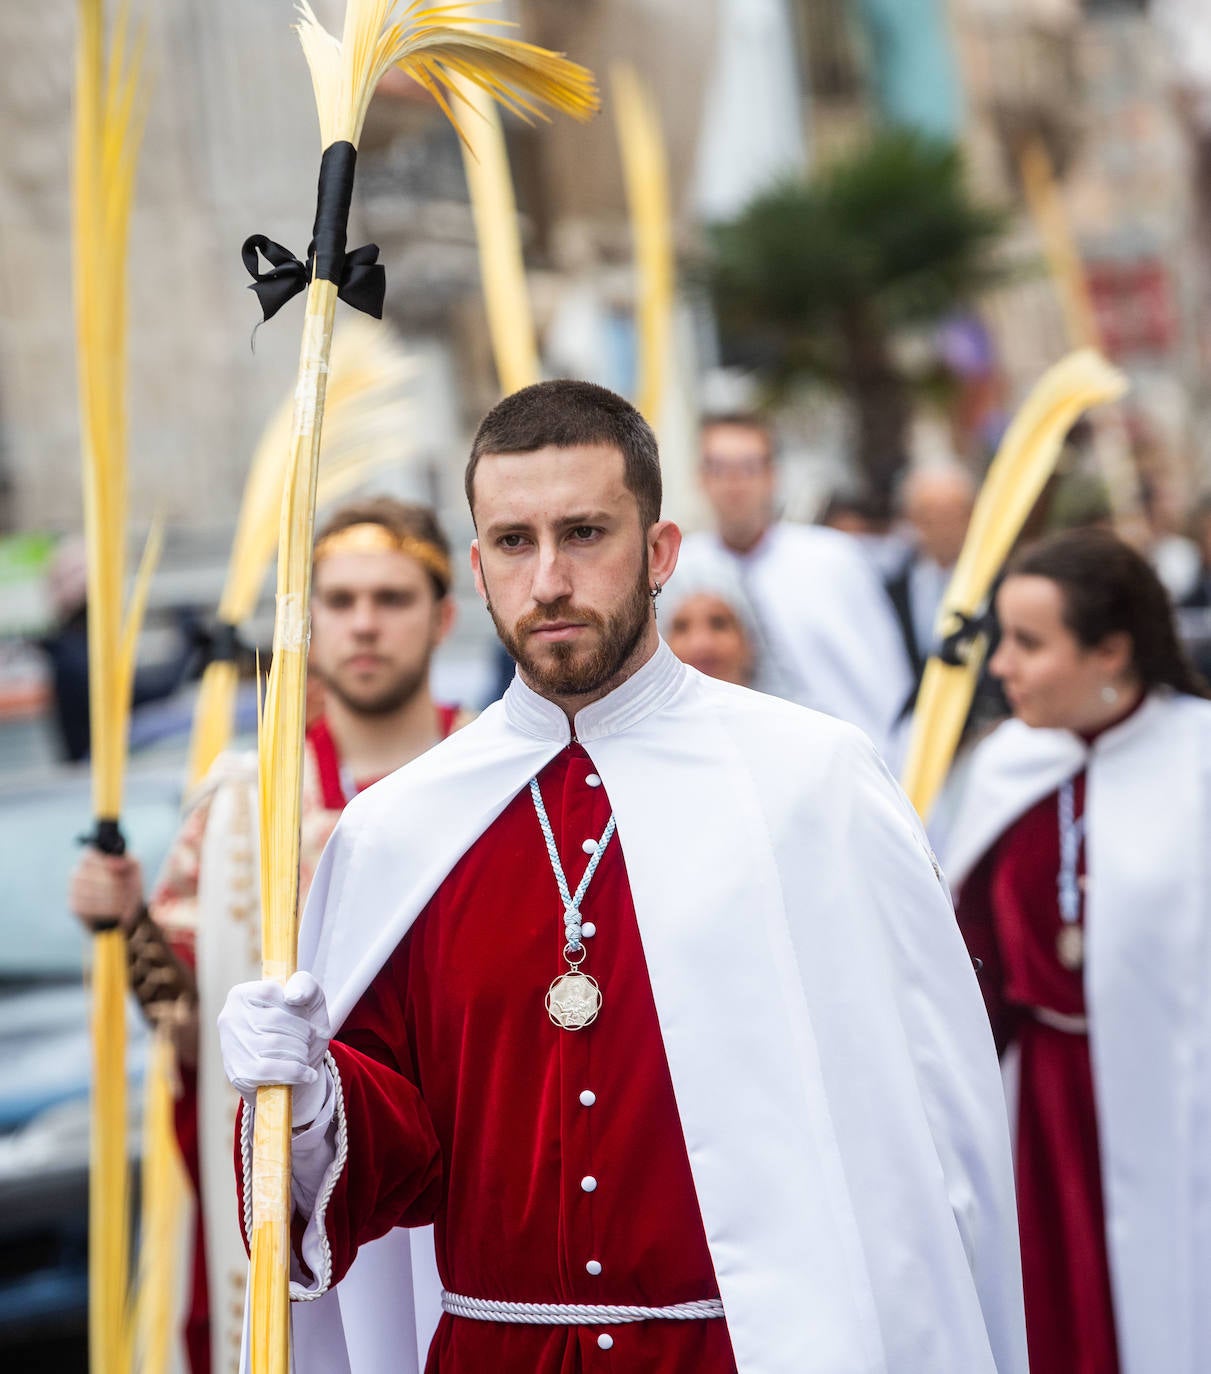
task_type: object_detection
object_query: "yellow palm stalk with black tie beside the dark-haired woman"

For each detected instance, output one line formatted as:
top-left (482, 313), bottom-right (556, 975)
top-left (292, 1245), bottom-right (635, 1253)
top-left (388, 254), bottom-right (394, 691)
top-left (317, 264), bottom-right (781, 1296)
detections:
top-left (902, 349), bottom-right (1127, 820)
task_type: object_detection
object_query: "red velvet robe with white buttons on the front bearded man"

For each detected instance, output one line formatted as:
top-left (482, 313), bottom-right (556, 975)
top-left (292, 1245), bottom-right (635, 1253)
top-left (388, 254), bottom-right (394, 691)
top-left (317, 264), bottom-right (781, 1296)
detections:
top-left (265, 745), bottom-right (735, 1374)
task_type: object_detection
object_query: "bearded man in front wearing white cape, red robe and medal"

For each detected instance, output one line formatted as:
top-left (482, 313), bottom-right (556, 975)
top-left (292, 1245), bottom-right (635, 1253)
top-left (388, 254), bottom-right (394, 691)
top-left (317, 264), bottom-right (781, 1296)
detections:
top-left (220, 381), bottom-right (1025, 1374)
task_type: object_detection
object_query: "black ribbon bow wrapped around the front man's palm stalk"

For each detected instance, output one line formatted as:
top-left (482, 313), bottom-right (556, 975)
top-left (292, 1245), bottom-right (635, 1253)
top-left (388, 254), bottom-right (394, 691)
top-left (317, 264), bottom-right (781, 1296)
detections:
top-left (239, 142), bottom-right (386, 320)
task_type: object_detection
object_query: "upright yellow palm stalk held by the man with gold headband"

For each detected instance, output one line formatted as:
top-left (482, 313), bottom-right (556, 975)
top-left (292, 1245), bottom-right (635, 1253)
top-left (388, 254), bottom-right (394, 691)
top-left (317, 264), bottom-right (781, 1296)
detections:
top-left (71, 0), bottom-right (158, 1374)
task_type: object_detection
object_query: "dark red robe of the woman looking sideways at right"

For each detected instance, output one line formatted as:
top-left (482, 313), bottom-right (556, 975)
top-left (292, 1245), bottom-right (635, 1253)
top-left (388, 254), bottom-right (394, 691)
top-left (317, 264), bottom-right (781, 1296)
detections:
top-left (958, 772), bottom-right (1119, 1374)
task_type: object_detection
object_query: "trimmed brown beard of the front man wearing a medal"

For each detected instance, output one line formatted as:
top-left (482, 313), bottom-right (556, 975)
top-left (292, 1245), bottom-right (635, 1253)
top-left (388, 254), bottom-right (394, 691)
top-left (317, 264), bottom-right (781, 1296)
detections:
top-left (488, 567), bottom-right (652, 697)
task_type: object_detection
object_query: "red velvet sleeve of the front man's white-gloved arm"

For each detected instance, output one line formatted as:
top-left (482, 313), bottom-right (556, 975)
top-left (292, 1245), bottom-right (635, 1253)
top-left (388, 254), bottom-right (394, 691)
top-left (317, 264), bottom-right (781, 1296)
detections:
top-left (236, 941), bottom-right (443, 1283)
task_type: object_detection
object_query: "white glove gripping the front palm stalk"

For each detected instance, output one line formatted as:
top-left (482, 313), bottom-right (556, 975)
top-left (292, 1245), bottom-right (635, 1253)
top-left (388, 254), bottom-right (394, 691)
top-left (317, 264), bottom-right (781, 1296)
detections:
top-left (219, 973), bottom-right (333, 1127)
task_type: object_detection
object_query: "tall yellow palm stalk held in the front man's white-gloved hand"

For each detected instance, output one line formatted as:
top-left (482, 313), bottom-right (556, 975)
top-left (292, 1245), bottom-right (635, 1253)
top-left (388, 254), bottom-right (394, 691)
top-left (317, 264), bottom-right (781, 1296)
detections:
top-left (250, 0), bottom-right (595, 1374)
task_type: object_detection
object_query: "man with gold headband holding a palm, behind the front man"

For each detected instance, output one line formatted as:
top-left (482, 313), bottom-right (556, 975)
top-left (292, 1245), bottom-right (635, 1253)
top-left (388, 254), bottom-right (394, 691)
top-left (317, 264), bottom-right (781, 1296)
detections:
top-left (64, 497), bottom-right (467, 1374)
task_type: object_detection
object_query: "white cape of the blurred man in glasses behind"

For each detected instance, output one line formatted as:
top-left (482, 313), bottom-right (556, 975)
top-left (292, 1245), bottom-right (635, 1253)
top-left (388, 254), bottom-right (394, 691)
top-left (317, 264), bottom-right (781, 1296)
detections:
top-left (671, 522), bottom-right (913, 757)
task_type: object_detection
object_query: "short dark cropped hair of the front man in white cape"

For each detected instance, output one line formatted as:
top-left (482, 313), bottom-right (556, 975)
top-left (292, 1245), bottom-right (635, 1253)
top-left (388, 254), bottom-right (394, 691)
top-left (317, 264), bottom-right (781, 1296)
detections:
top-left (465, 378), bottom-right (661, 529)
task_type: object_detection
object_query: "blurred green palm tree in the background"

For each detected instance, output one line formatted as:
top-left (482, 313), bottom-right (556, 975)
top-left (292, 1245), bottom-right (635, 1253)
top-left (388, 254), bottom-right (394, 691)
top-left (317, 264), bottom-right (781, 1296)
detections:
top-left (708, 129), bottom-right (1008, 502)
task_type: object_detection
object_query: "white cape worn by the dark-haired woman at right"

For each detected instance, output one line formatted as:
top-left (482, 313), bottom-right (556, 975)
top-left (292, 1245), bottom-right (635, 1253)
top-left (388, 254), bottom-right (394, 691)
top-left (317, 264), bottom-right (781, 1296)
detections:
top-left (944, 694), bottom-right (1211, 1374)
